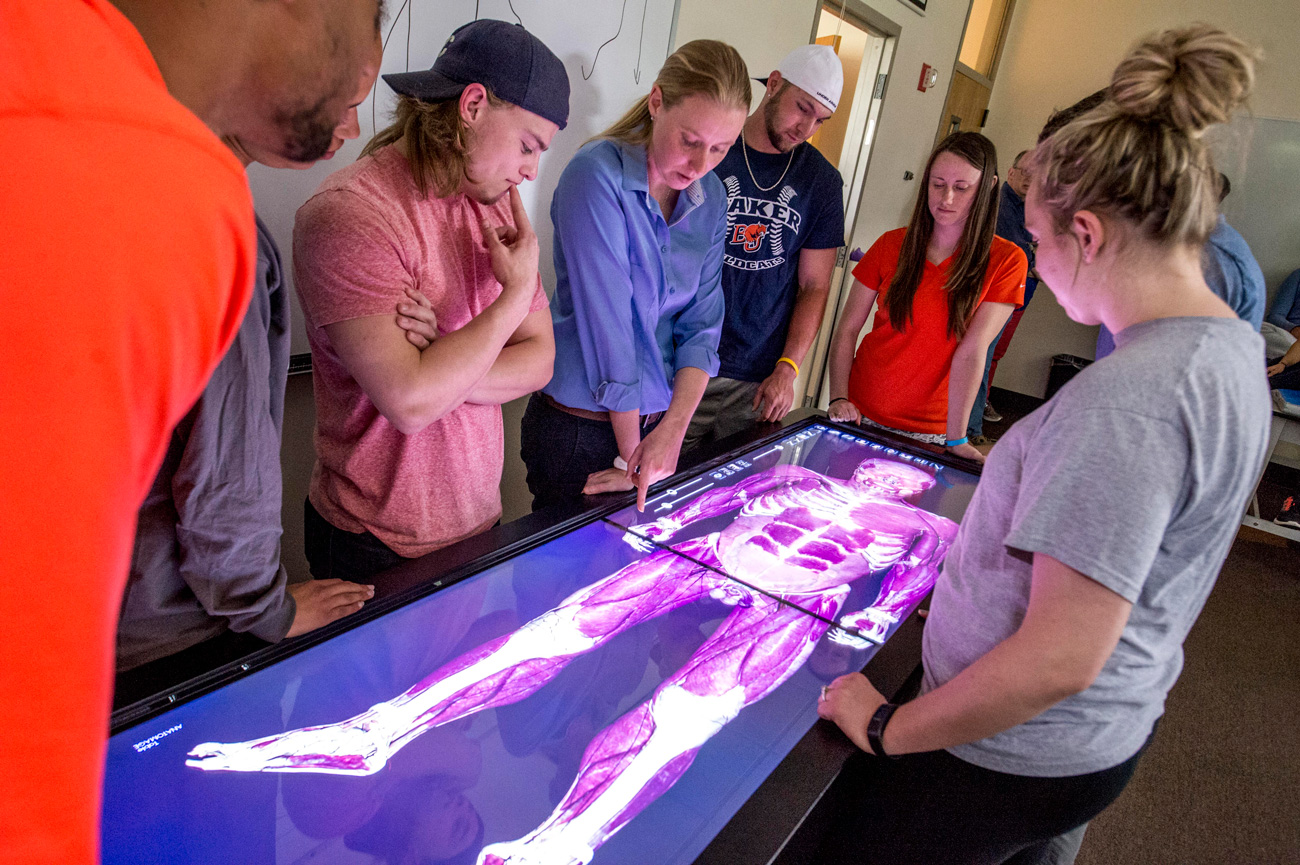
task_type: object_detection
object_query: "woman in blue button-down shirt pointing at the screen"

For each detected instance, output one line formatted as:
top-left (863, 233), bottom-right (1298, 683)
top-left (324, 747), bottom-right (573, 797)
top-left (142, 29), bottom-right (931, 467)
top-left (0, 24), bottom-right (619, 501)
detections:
top-left (523, 39), bottom-right (750, 510)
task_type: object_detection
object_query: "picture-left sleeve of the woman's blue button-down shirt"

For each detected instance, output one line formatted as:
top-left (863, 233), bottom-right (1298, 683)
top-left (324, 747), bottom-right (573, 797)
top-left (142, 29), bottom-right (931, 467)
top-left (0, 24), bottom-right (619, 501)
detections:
top-left (551, 152), bottom-right (641, 411)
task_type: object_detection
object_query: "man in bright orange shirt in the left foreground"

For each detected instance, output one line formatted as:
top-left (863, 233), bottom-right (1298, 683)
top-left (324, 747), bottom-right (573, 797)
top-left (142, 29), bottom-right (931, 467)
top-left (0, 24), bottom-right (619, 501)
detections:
top-left (0, 0), bottom-right (380, 865)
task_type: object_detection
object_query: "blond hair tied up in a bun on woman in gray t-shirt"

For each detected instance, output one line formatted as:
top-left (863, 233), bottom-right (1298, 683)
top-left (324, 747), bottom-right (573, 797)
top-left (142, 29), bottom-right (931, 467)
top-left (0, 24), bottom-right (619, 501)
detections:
top-left (1031, 23), bottom-right (1257, 246)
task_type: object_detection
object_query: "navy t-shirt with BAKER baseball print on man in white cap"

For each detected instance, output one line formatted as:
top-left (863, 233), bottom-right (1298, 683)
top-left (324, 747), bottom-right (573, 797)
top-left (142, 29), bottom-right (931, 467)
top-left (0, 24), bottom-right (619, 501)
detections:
top-left (714, 138), bottom-right (844, 381)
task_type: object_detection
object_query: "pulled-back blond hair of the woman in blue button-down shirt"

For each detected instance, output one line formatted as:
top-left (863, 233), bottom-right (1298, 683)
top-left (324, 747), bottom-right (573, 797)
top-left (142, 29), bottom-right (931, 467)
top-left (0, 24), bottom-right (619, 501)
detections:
top-left (597, 39), bottom-right (753, 146)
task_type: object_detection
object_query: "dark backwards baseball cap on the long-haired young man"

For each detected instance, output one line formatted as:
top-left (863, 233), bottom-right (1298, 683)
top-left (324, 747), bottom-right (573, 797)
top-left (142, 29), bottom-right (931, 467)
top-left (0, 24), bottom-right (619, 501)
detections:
top-left (384, 18), bottom-right (569, 129)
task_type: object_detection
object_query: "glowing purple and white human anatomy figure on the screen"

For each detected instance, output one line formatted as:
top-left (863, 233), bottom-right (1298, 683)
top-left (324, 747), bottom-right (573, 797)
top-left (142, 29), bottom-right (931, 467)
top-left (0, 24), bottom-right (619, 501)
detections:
top-left (186, 458), bottom-right (957, 865)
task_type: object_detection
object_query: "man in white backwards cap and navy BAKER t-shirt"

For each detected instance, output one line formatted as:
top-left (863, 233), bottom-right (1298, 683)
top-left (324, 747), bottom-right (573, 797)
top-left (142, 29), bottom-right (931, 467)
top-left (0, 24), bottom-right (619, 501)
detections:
top-left (684, 46), bottom-right (844, 449)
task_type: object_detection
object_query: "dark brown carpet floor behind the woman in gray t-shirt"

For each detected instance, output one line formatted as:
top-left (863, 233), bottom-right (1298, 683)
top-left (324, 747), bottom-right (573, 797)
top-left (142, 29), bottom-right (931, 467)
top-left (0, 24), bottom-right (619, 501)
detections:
top-left (1076, 528), bottom-right (1300, 865)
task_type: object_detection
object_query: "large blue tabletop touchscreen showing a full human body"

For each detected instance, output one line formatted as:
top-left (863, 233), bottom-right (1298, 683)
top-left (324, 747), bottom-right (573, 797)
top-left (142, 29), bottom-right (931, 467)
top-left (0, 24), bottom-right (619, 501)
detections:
top-left (103, 424), bottom-right (976, 865)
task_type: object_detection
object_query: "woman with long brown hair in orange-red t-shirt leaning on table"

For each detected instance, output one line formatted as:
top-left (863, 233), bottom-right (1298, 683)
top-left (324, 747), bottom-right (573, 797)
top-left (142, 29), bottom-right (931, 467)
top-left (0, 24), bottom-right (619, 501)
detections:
top-left (829, 133), bottom-right (1028, 462)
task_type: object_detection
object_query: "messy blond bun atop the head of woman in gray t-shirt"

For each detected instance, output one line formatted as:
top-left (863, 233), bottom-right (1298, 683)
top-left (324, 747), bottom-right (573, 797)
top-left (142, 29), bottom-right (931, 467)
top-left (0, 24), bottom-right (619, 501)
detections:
top-left (1110, 23), bottom-right (1257, 135)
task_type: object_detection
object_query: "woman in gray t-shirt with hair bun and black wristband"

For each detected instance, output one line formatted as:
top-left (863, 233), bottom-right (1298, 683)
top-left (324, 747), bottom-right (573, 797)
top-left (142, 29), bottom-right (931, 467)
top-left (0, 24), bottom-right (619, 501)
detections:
top-left (819, 25), bottom-right (1269, 865)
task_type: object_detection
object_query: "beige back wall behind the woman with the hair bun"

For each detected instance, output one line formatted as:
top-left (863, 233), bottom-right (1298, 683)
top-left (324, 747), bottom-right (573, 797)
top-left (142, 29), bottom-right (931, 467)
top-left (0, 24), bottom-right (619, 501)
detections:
top-left (984, 0), bottom-right (1300, 395)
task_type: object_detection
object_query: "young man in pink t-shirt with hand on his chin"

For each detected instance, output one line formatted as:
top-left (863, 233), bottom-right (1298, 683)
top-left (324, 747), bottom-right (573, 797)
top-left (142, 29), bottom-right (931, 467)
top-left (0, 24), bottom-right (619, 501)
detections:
top-left (294, 20), bottom-right (568, 580)
